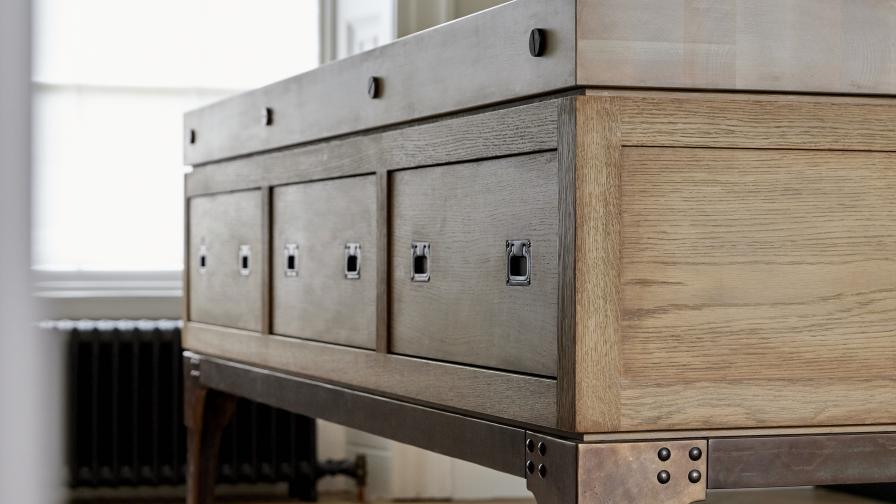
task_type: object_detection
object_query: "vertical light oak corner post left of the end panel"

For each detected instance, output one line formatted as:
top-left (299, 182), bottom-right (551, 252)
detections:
top-left (575, 98), bottom-right (622, 432)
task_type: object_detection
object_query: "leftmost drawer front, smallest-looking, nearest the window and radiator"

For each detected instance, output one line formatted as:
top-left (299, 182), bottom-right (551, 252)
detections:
top-left (189, 190), bottom-right (265, 331)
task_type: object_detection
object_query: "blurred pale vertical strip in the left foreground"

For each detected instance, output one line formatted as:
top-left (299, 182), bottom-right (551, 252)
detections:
top-left (0, 0), bottom-right (61, 504)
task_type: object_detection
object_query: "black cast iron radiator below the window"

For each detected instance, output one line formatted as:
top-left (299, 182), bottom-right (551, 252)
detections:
top-left (41, 320), bottom-right (317, 499)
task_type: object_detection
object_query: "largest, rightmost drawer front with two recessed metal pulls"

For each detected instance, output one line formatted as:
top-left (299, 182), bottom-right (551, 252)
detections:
top-left (390, 152), bottom-right (559, 376)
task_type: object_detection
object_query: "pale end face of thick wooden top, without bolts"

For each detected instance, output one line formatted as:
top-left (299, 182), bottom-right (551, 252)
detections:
top-left (576, 0), bottom-right (896, 94)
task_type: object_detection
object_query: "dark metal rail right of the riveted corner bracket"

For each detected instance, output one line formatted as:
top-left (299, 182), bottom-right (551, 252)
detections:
top-left (708, 434), bottom-right (896, 489)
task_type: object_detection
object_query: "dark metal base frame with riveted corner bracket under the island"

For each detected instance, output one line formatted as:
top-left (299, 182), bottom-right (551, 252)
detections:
top-left (184, 352), bottom-right (896, 504)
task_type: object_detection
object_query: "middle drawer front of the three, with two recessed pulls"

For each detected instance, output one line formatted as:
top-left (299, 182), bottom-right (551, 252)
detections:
top-left (272, 175), bottom-right (377, 348)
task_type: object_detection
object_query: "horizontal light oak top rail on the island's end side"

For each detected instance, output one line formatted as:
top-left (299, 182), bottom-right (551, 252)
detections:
top-left (620, 95), bottom-right (896, 151)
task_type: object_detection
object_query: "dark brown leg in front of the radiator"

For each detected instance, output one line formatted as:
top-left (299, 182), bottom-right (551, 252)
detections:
top-left (184, 359), bottom-right (236, 504)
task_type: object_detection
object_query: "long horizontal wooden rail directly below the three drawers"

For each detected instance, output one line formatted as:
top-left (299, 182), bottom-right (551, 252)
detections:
top-left (183, 323), bottom-right (557, 427)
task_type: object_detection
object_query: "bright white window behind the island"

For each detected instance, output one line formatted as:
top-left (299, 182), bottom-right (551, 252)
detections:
top-left (33, 0), bottom-right (320, 272)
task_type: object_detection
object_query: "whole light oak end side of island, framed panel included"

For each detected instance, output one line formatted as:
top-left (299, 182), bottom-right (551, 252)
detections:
top-left (576, 96), bottom-right (896, 432)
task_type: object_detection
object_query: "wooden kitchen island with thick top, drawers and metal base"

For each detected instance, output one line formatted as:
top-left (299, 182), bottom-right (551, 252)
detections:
top-left (184, 0), bottom-right (896, 504)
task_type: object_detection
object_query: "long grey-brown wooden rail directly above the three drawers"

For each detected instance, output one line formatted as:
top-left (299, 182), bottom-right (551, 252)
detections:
top-left (186, 100), bottom-right (558, 196)
